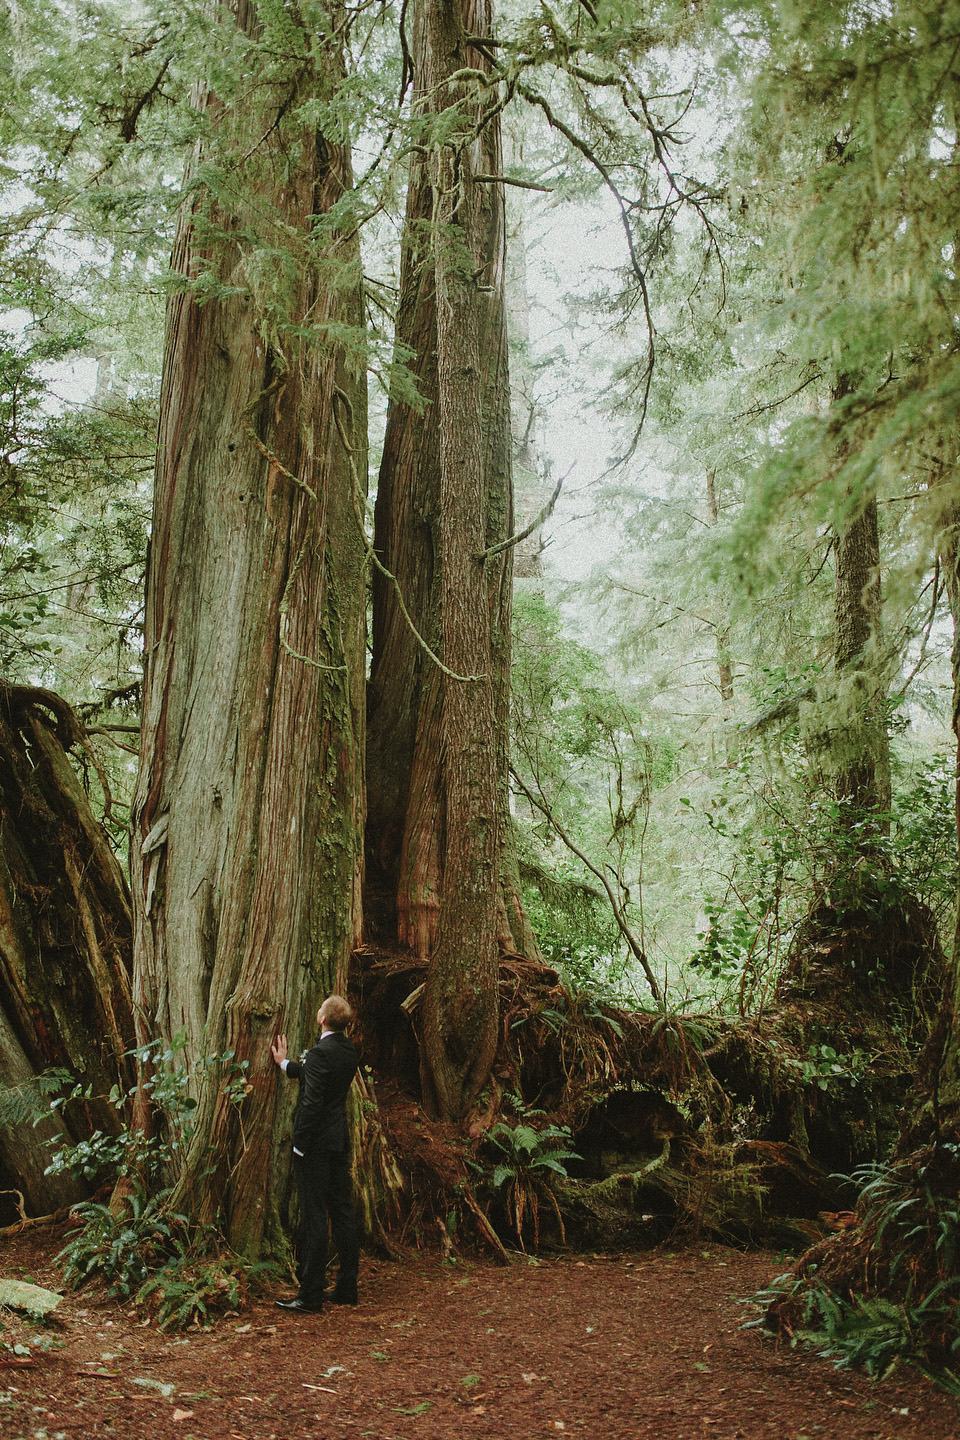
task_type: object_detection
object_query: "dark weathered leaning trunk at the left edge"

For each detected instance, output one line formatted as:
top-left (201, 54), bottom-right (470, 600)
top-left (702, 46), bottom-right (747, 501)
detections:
top-left (0, 685), bottom-right (134, 1212)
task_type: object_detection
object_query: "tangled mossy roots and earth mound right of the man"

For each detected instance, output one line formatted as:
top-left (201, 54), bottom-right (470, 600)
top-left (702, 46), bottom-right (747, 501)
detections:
top-left (351, 921), bottom-right (938, 1248)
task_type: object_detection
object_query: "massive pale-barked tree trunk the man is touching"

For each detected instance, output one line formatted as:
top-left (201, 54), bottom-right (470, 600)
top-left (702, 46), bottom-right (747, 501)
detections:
top-left (132, 0), bottom-right (366, 1254)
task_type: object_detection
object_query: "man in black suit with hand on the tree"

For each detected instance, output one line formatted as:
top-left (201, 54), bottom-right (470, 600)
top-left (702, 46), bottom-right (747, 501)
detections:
top-left (271, 995), bottom-right (360, 1310)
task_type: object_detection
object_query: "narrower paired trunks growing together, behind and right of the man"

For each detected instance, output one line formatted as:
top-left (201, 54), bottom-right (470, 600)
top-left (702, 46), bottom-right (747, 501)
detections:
top-left (367, 0), bottom-right (535, 1117)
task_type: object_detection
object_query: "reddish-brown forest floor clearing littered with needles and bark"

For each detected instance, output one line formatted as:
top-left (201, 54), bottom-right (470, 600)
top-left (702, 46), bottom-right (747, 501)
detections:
top-left (0, 1227), bottom-right (960, 1440)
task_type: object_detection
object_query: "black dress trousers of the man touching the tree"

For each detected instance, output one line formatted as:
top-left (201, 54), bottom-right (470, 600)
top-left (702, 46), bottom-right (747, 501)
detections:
top-left (294, 1151), bottom-right (360, 1306)
